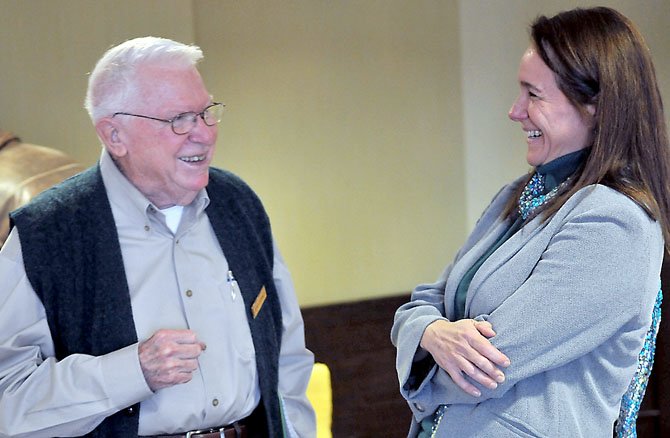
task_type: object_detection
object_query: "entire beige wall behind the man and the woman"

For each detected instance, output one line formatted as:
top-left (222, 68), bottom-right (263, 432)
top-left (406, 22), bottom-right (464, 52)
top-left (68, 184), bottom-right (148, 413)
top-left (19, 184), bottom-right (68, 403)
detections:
top-left (0, 0), bottom-right (670, 305)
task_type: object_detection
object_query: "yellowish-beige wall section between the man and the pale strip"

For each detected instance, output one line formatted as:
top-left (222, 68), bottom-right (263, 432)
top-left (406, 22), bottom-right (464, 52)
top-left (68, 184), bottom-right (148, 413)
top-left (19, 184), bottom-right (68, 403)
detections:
top-left (195, 0), bottom-right (465, 304)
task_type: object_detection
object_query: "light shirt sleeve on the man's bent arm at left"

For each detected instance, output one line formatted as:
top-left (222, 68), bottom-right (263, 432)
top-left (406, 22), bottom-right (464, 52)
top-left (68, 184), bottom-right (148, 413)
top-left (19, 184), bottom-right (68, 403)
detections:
top-left (0, 229), bottom-right (151, 438)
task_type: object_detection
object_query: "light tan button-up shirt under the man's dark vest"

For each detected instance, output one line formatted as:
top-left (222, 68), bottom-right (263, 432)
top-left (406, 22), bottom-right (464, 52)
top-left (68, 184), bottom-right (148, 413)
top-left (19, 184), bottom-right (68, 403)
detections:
top-left (0, 152), bottom-right (315, 437)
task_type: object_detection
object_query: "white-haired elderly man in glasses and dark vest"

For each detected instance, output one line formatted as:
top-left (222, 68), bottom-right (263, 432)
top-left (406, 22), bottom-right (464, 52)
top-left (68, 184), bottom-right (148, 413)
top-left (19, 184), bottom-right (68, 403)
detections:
top-left (0, 37), bottom-right (315, 438)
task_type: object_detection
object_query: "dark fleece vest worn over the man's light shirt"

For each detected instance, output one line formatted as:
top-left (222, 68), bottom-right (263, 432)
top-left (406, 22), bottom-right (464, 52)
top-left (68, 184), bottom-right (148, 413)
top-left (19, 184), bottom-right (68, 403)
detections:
top-left (10, 166), bottom-right (283, 438)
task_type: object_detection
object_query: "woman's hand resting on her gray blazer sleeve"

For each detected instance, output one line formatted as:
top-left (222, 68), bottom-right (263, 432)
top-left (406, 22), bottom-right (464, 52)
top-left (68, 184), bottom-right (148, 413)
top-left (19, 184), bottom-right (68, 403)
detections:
top-left (421, 319), bottom-right (510, 397)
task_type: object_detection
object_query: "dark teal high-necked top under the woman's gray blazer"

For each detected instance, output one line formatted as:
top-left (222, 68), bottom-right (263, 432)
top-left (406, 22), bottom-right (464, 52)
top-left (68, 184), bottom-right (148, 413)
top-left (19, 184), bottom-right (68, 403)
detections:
top-left (454, 149), bottom-right (588, 320)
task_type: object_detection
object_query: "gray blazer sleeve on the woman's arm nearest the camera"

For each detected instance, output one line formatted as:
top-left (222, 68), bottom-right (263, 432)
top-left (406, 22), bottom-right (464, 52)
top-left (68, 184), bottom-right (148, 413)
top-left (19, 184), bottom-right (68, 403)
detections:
top-left (404, 186), bottom-right (663, 415)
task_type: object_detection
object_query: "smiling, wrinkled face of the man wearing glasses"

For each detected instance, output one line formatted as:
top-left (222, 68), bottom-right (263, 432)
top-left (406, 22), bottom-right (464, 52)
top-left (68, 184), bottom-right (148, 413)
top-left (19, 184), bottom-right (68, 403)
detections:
top-left (110, 66), bottom-right (217, 208)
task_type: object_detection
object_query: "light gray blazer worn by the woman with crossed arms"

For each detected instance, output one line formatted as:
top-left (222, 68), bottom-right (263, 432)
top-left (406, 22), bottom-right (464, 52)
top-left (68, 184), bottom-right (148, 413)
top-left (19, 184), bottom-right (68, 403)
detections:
top-left (391, 178), bottom-right (663, 438)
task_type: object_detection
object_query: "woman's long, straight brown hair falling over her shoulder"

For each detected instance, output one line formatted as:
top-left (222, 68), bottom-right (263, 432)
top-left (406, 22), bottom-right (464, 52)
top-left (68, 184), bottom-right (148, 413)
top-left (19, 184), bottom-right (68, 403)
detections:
top-left (505, 7), bottom-right (670, 250)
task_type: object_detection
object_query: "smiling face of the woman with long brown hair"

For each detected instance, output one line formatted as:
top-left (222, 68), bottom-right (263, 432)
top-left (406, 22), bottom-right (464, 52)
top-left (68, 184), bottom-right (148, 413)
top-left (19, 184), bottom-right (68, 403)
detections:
top-left (509, 46), bottom-right (595, 167)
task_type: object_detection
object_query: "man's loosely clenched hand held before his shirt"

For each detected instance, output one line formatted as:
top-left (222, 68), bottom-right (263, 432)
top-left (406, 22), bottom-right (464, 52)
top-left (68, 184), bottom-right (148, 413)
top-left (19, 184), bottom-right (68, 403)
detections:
top-left (139, 329), bottom-right (207, 392)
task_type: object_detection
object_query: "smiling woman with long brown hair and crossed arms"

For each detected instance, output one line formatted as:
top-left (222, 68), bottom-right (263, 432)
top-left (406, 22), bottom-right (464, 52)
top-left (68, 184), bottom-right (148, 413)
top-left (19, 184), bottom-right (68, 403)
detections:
top-left (391, 8), bottom-right (670, 437)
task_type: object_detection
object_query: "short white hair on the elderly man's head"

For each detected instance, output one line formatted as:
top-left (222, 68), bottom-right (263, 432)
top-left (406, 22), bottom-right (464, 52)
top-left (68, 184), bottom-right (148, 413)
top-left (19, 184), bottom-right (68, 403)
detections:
top-left (84, 36), bottom-right (203, 124)
